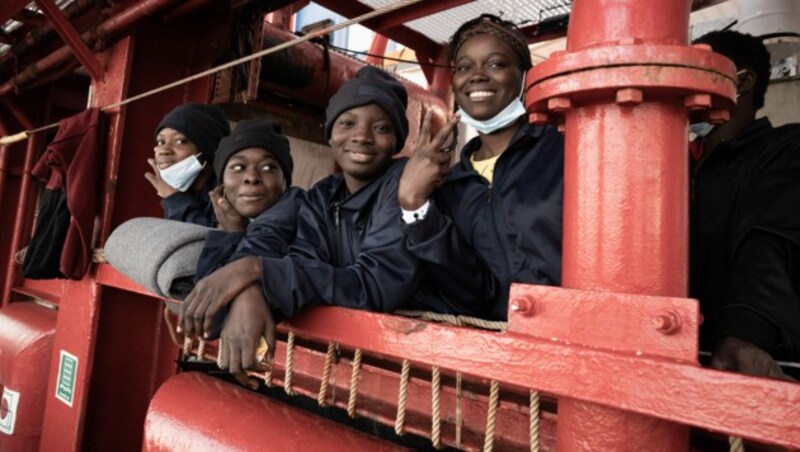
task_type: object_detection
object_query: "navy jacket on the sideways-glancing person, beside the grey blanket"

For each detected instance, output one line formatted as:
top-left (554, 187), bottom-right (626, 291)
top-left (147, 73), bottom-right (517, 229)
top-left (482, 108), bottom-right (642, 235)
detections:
top-left (195, 187), bottom-right (304, 281)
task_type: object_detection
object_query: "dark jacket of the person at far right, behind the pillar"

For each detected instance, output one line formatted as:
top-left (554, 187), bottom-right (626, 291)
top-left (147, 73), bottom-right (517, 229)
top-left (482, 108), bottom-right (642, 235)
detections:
top-left (689, 118), bottom-right (800, 360)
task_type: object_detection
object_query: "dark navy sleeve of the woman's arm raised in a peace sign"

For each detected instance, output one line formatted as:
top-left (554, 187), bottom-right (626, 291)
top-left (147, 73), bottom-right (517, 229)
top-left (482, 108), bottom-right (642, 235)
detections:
top-left (406, 200), bottom-right (500, 316)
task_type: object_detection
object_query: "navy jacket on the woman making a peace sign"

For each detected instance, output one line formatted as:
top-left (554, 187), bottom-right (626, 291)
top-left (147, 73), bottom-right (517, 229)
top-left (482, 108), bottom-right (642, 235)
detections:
top-left (405, 123), bottom-right (564, 320)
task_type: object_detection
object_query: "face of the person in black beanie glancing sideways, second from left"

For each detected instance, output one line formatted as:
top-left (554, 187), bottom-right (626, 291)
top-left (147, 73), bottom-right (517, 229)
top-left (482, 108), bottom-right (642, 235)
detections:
top-left (222, 148), bottom-right (285, 218)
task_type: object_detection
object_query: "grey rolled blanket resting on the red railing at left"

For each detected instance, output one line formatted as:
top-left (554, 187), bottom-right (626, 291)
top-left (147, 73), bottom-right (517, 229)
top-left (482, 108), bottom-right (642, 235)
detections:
top-left (103, 217), bottom-right (210, 300)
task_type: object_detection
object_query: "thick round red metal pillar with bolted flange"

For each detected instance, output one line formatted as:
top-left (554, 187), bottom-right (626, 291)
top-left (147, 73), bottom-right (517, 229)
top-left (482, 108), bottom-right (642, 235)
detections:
top-left (528, 0), bottom-right (733, 451)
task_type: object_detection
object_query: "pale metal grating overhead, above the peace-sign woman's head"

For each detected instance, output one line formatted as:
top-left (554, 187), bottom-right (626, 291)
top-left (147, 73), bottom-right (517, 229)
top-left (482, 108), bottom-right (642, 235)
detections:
top-left (361, 0), bottom-right (572, 43)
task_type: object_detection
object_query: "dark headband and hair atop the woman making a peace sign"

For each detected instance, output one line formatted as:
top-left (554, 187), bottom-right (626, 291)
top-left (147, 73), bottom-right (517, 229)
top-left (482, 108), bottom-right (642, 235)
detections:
top-left (447, 14), bottom-right (533, 71)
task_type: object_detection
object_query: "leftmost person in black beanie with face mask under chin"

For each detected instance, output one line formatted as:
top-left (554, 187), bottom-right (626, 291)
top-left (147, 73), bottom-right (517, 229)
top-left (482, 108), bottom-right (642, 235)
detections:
top-left (145, 102), bottom-right (230, 226)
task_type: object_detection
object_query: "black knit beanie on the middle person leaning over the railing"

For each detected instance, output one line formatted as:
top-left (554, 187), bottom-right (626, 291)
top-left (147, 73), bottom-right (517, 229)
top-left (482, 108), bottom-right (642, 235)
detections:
top-left (325, 66), bottom-right (408, 152)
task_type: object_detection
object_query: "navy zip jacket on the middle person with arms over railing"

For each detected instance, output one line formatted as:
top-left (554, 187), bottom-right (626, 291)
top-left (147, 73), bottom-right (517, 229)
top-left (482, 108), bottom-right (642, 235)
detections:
top-left (261, 159), bottom-right (466, 317)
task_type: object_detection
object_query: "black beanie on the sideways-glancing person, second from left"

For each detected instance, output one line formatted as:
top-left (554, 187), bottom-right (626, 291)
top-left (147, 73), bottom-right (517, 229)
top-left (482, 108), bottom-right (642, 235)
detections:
top-left (214, 119), bottom-right (294, 187)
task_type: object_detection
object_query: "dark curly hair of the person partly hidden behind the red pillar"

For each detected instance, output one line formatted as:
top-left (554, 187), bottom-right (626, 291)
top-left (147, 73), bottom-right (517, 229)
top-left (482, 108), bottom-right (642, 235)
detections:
top-left (695, 30), bottom-right (770, 110)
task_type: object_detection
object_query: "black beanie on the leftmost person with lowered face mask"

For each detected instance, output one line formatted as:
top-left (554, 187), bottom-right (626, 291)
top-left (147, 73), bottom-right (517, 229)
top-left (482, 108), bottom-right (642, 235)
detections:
top-left (156, 102), bottom-right (231, 164)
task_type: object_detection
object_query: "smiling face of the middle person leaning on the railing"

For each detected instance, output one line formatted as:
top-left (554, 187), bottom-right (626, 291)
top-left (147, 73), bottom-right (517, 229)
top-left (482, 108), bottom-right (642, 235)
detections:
top-left (328, 104), bottom-right (396, 193)
